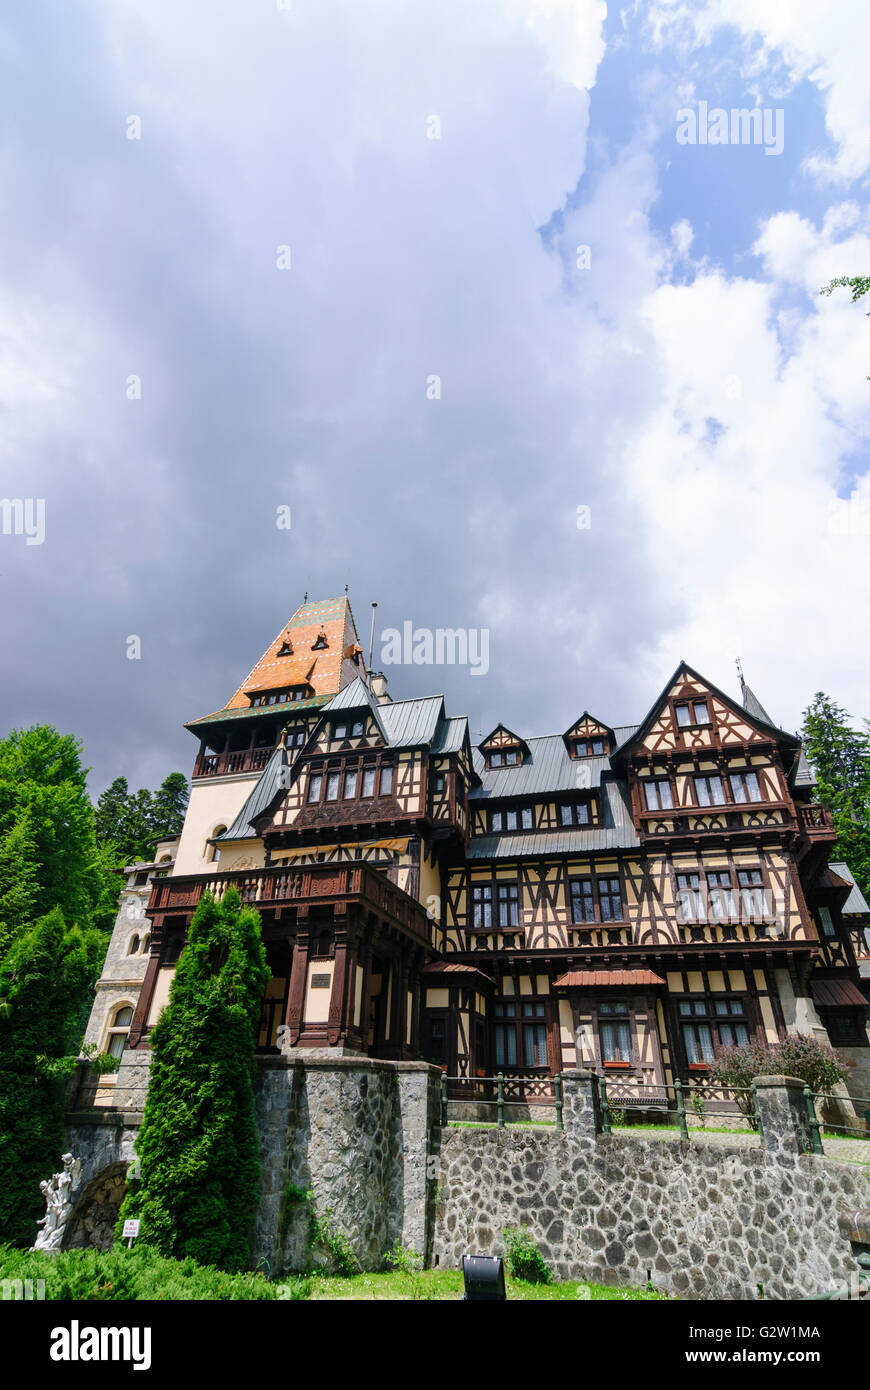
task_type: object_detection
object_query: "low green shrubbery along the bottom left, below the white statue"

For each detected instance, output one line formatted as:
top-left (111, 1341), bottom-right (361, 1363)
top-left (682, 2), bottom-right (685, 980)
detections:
top-left (0, 1245), bottom-right (273, 1302)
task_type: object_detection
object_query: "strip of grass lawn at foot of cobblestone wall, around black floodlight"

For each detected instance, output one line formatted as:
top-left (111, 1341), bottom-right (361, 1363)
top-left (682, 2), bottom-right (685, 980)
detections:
top-left (278, 1269), bottom-right (667, 1301)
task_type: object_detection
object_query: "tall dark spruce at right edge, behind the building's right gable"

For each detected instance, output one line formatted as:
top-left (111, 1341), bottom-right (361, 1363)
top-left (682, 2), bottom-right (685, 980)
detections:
top-left (801, 691), bottom-right (870, 895)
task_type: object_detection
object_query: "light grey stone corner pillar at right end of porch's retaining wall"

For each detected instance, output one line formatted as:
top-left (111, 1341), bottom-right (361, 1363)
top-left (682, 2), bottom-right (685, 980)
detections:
top-left (391, 1062), bottom-right (441, 1261)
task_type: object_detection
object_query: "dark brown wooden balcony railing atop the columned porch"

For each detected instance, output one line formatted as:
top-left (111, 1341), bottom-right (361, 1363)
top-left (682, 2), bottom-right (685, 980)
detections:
top-left (147, 863), bottom-right (438, 949)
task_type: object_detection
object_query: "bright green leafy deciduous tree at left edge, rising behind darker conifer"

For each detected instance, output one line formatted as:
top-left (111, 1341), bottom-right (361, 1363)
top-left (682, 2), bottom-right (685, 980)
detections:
top-left (0, 724), bottom-right (114, 951)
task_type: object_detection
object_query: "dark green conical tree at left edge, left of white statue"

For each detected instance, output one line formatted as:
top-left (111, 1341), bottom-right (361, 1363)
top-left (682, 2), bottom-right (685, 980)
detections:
top-left (0, 908), bottom-right (104, 1245)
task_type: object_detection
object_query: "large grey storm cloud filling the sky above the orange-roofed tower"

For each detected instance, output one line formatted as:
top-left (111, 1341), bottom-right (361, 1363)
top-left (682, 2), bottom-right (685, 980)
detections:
top-left (0, 0), bottom-right (691, 790)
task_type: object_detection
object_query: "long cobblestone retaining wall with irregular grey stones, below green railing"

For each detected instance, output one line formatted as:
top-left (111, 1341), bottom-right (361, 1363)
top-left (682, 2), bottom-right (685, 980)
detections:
top-left (432, 1129), bottom-right (870, 1298)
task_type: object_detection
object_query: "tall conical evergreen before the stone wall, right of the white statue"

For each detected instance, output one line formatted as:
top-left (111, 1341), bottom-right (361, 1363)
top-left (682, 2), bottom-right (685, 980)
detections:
top-left (118, 890), bottom-right (268, 1272)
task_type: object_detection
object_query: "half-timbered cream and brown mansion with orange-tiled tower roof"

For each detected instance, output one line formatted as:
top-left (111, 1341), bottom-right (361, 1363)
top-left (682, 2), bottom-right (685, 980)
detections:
top-left (91, 598), bottom-right (870, 1112)
